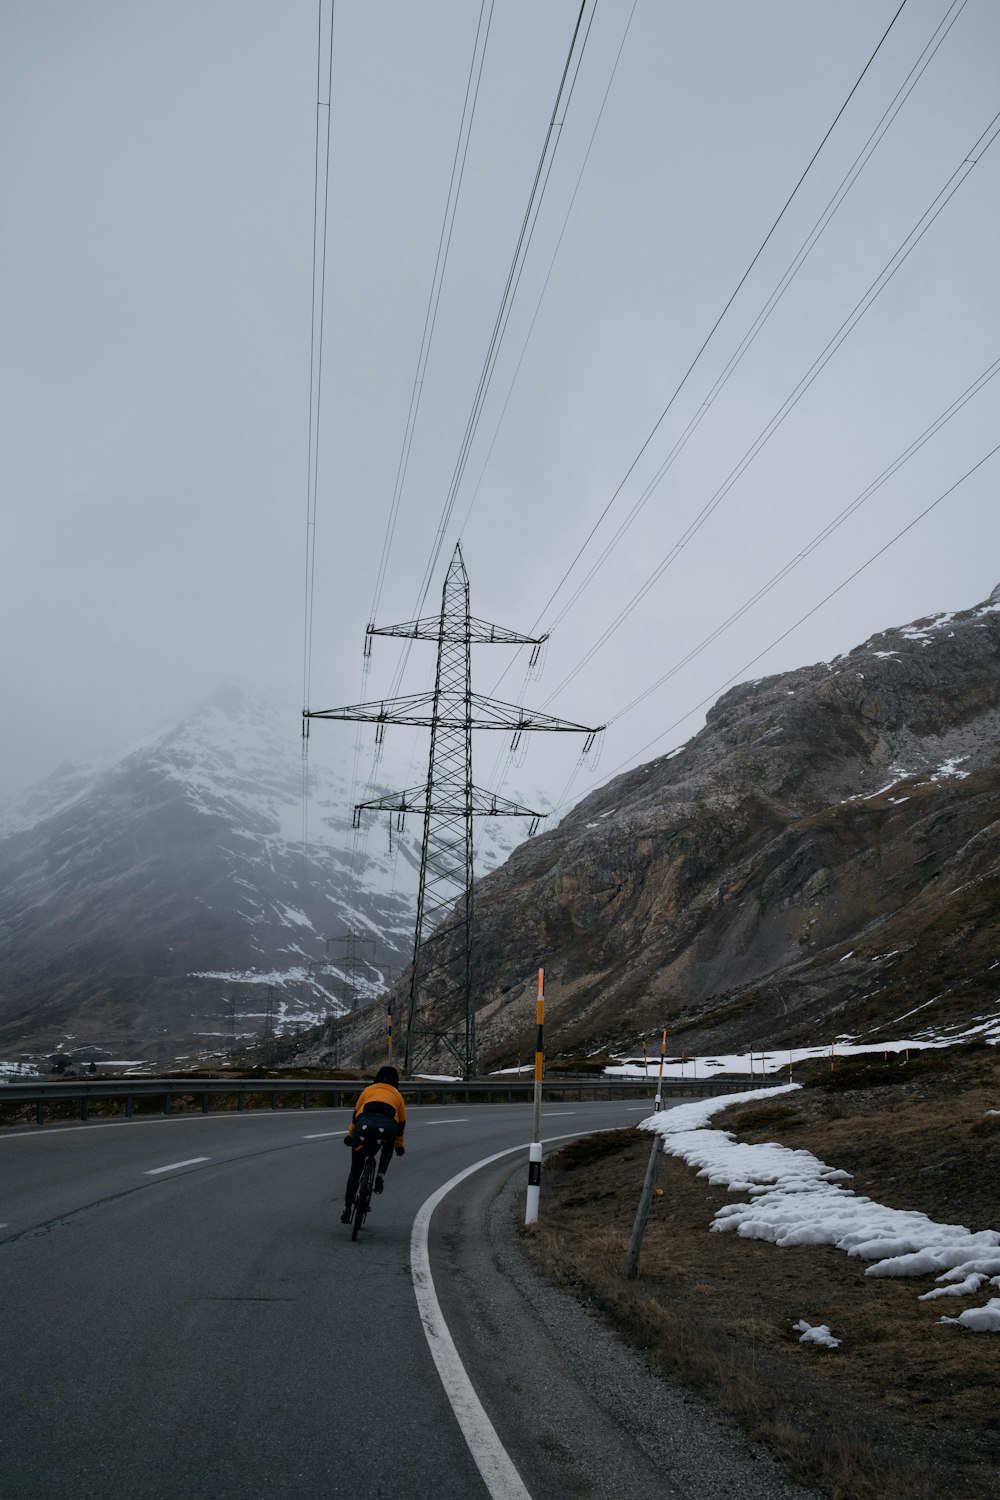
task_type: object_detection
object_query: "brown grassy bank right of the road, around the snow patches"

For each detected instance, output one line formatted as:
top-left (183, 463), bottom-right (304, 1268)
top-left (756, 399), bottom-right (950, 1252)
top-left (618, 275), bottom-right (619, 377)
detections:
top-left (523, 1047), bottom-right (1000, 1500)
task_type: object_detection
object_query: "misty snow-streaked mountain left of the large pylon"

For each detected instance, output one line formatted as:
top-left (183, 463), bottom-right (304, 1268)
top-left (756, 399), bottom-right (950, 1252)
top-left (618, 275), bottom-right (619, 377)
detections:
top-left (0, 687), bottom-right (542, 1058)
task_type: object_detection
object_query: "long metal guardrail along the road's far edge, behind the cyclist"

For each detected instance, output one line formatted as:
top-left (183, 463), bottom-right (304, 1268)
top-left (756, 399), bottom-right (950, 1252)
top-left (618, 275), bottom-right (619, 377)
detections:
top-left (0, 1076), bottom-right (780, 1125)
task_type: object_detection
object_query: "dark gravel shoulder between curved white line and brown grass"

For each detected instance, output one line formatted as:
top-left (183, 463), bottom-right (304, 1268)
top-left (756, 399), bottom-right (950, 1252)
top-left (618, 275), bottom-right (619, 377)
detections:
top-left (432, 1163), bottom-right (814, 1500)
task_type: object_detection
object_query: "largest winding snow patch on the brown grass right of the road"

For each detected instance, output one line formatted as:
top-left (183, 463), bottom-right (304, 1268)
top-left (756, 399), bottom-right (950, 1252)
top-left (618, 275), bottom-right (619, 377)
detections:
top-left (640, 1083), bottom-right (1000, 1332)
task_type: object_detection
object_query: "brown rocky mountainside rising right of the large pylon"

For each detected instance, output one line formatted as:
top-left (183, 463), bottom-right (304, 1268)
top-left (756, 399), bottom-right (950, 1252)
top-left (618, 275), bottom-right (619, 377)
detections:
top-left (419, 588), bottom-right (1000, 1061)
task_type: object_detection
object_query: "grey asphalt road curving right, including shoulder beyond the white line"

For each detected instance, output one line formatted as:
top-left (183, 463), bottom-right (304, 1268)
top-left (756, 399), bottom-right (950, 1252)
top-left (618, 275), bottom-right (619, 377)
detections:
top-left (0, 1101), bottom-right (815, 1500)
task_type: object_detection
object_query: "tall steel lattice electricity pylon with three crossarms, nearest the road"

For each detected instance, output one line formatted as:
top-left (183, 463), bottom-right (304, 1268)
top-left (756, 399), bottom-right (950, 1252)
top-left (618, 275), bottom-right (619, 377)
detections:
top-left (303, 545), bottom-right (600, 1077)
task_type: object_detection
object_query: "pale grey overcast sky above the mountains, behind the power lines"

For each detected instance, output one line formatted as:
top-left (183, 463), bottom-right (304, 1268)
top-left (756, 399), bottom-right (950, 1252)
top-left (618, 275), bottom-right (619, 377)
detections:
top-left (0, 0), bottom-right (1000, 822)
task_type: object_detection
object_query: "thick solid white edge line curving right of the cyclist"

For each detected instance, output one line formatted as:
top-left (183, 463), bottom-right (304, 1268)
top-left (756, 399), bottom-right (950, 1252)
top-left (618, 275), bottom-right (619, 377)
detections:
top-left (409, 1127), bottom-right (613, 1500)
